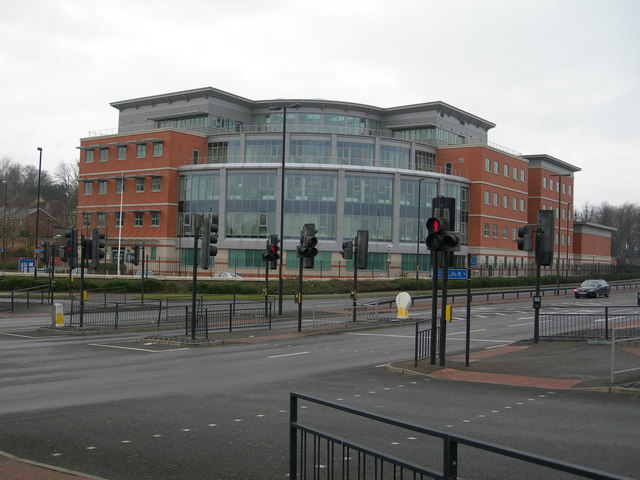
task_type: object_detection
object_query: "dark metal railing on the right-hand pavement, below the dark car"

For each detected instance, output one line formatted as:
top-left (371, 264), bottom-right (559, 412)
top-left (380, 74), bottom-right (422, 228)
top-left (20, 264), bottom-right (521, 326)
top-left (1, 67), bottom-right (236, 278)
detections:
top-left (540, 306), bottom-right (640, 340)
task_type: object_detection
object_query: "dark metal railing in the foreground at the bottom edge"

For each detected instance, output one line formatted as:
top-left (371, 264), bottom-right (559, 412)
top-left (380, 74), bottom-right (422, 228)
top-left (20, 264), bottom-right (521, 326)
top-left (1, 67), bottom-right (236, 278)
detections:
top-left (289, 393), bottom-right (623, 480)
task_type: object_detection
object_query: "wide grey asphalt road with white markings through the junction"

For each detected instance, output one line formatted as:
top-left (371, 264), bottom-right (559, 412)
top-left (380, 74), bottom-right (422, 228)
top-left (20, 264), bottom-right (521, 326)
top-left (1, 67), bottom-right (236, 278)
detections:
top-left (0, 292), bottom-right (640, 480)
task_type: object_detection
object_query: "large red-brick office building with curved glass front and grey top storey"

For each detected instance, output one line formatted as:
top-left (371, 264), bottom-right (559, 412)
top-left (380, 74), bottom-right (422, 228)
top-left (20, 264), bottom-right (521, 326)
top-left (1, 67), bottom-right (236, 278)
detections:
top-left (78, 84), bottom-right (611, 276)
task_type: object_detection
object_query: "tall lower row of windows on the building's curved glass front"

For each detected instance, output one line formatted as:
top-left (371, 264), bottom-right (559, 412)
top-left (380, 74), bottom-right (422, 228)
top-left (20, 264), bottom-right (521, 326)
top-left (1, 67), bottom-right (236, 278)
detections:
top-left (177, 171), bottom-right (468, 242)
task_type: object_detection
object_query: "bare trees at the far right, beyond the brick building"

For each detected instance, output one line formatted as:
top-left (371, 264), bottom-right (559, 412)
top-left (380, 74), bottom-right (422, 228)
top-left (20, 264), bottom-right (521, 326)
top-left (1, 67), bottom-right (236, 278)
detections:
top-left (575, 202), bottom-right (640, 265)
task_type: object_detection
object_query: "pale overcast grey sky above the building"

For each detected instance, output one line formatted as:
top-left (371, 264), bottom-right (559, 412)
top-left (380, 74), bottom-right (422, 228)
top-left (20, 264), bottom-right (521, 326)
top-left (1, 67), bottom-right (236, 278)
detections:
top-left (0, 0), bottom-right (640, 208)
